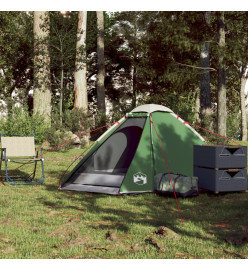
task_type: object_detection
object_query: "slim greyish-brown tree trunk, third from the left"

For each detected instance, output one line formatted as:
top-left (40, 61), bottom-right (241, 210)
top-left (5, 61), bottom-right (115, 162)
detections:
top-left (96, 11), bottom-right (106, 115)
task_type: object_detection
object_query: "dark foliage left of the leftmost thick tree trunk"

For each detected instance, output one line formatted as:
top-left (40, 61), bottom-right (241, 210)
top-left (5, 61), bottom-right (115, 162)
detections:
top-left (0, 11), bottom-right (33, 111)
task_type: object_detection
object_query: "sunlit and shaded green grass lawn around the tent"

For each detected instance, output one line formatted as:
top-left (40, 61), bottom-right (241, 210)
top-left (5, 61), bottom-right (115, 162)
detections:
top-left (0, 143), bottom-right (248, 259)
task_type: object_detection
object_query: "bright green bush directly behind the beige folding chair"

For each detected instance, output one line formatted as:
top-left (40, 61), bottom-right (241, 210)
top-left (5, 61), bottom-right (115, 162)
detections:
top-left (0, 108), bottom-right (47, 144)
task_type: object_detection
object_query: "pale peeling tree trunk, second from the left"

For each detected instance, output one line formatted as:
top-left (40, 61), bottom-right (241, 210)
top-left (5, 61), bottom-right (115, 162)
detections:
top-left (74, 11), bottom-right (88, 112)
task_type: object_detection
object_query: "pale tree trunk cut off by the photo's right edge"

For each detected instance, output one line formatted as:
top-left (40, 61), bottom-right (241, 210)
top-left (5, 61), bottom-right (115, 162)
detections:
top-left (240, 70), bottom-right (247, 141)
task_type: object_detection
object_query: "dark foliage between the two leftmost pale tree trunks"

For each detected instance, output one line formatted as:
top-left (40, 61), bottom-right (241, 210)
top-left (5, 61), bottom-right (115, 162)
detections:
top-left (50, 11), bottom-right (77, 111)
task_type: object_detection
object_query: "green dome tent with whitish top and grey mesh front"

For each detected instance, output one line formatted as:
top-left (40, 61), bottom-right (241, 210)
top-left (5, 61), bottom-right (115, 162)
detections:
top-left (60, 104), bottom-right (204, 194)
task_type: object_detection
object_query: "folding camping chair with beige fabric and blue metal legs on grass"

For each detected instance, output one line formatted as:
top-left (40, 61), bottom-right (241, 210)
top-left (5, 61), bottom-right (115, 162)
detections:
top-left (0, 134), bottom-right (45, 185)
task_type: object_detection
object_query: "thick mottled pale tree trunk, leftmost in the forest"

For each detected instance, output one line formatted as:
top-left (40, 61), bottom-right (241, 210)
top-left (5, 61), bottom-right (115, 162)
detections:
top-left (33, 11), bottom-right (52, 123)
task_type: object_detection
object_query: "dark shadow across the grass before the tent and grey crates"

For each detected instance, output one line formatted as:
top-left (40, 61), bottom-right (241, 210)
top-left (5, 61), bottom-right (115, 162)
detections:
top-left (40, 177), bottom-right (248, 247)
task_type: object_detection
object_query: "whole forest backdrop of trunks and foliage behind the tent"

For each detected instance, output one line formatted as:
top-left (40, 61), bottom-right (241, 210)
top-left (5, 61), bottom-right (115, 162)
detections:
top-left (0, 8), bottom-right (248, 146)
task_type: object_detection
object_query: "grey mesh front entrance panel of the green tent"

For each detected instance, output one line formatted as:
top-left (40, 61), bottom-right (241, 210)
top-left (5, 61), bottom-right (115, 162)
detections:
top-left (66, 117), bottom-right (146, 189)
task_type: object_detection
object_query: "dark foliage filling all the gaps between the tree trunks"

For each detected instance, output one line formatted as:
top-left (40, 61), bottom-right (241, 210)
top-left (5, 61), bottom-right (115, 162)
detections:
top-left (0, 11), bottom-right (248, 141)
